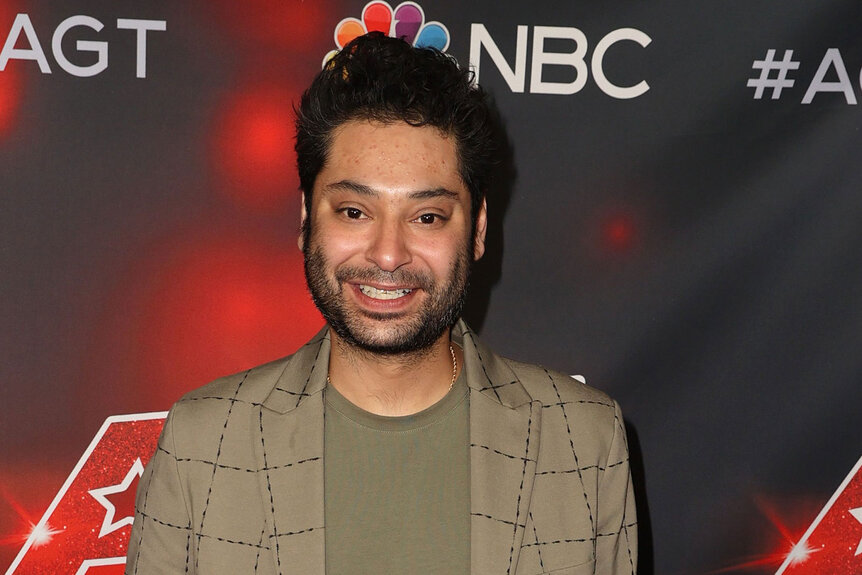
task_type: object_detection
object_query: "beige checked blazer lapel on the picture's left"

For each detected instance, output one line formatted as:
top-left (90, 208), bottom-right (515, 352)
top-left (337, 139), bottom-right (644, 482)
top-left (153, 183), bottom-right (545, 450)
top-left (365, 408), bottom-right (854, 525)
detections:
top-left (250, 328), bottom-right (330, 575)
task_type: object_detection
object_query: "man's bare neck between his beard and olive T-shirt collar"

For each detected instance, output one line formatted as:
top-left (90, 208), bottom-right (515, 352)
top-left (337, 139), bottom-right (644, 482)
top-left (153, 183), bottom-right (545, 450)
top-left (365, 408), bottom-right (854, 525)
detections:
top-left (329, 330), bottom-right (462, 416)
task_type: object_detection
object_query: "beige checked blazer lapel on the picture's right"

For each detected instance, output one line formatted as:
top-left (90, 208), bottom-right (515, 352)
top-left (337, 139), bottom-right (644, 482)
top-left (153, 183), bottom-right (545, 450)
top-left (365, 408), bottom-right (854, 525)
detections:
top-left (453, 322), bottom-right (541, 575)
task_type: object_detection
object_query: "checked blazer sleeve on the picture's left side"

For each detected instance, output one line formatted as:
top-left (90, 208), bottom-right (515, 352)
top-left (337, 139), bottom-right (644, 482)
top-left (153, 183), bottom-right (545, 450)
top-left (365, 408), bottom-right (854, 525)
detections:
top-left (125, 410), bottom-right (194, 575)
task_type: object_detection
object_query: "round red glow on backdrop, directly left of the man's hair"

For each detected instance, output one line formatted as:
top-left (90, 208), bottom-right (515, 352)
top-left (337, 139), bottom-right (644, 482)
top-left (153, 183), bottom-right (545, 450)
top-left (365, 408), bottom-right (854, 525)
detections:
top-left (214, 87), bottom-right (299, 210)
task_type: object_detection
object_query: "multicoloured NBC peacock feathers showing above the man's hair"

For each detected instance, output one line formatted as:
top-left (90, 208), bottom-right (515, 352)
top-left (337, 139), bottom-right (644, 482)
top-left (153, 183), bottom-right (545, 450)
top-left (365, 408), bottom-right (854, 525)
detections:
top-left (323, 0), bottom-right (449, 66)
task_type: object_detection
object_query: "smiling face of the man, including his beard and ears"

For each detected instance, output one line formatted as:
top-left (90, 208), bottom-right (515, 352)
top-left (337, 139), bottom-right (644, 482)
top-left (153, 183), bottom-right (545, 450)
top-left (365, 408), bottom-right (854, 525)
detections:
top-left (301, 120), bottom-right (486, 354)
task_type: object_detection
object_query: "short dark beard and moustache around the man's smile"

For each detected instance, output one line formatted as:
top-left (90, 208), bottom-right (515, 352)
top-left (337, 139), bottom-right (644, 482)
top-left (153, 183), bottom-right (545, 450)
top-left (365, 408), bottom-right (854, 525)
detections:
top-left (303, 234), bottom-right (471, 355)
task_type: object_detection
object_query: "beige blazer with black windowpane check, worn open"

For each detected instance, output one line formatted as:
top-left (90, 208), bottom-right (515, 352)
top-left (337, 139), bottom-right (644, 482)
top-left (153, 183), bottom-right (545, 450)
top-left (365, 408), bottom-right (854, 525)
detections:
top-left (126, 322), bottom-right (637, 575)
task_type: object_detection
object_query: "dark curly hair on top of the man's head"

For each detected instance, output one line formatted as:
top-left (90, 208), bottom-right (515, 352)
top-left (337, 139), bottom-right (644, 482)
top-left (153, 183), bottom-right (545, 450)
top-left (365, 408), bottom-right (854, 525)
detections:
top-left (296, 32), bottom-right (493, 223)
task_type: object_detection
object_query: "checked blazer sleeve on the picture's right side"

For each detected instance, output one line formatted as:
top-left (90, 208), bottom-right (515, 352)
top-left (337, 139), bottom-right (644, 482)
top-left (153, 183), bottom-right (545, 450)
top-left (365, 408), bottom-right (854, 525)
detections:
top-left (596, 402), bottom-right (638, 575)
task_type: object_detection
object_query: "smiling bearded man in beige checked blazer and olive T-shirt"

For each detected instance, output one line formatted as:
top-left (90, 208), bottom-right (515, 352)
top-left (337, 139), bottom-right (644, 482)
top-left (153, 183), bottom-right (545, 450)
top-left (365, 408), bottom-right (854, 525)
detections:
top-left (127, 34), bottom-right (637, 575)
